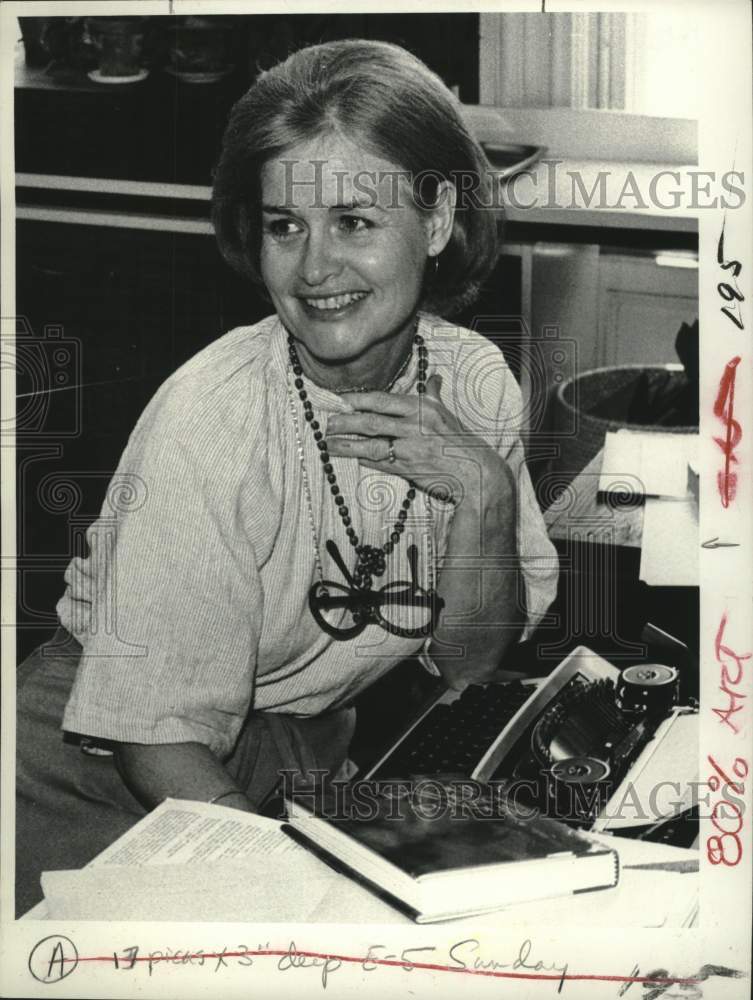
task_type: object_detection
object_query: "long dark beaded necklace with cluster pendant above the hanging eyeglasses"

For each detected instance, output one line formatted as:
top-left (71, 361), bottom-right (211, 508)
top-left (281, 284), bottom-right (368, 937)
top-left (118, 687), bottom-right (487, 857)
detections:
top-left (288, 333), bottom-right (429, 590)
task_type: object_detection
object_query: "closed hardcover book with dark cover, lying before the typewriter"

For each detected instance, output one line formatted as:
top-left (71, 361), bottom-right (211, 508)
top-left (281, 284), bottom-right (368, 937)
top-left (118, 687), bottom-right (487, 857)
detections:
top-left (284, 781), bottom-right (619, 923)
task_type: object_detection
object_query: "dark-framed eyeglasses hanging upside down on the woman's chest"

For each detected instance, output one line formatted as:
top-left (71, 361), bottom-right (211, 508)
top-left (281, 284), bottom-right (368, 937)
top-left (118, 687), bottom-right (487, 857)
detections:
top-left (309, 539), bottom-right (444, 641)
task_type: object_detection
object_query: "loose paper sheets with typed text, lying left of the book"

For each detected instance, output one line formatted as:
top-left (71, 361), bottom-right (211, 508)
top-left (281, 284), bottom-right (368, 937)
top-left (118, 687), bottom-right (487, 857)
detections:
top-left (21, 799), bottom-right (314, 920)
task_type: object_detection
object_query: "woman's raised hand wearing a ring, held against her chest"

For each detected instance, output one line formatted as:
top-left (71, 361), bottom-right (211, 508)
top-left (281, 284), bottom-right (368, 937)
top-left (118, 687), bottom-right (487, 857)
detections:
top-left (326, 375), bottom-right (510, 510)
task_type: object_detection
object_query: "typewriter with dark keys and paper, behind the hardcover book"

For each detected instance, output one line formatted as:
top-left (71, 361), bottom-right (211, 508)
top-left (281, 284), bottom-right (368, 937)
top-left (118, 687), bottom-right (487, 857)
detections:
top-left (364, 646), bottom-right (698, 839)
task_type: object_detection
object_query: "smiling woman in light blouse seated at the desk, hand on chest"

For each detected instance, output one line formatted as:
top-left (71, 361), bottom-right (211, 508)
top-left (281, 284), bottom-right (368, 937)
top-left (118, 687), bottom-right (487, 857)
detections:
top-left (18, 41), bottom-right (557, 905)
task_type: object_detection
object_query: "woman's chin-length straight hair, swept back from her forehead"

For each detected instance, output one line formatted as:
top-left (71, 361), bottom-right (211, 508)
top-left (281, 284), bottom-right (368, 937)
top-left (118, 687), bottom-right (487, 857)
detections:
top-left (212, 39), bottom-right (498, 316)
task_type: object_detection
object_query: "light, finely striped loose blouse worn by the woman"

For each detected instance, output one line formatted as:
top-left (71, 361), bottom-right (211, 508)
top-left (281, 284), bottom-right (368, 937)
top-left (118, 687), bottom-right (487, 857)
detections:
top-left (58, 315), bottom-right (557, 757)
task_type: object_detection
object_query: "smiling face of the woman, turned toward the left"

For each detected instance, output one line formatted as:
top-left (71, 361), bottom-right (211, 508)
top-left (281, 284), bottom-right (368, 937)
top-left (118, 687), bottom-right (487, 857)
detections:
top-left (261, 135), bottom-right (451, 364)
